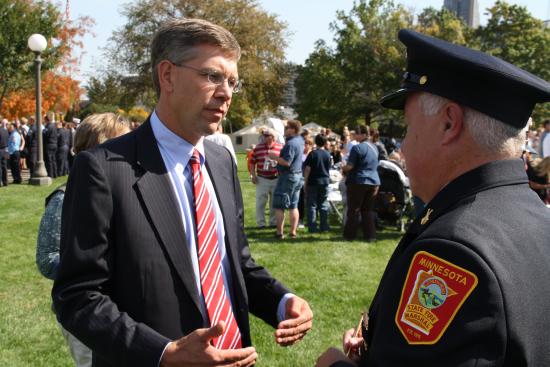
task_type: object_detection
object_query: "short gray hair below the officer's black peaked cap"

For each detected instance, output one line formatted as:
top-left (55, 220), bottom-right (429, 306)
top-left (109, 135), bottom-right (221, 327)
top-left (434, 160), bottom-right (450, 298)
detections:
top-left (418, 93), bottom-right (525, 157)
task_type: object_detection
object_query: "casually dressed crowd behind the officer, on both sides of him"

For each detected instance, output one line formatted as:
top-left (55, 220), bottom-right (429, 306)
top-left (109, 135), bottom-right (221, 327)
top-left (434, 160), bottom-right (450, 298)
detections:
top-left (247, 116), bottom-right (550, 242)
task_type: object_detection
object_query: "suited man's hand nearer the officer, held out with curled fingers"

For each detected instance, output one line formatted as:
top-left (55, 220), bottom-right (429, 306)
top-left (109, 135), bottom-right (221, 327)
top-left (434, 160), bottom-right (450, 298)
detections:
top-left (275, 296), bottom-right (313, 347)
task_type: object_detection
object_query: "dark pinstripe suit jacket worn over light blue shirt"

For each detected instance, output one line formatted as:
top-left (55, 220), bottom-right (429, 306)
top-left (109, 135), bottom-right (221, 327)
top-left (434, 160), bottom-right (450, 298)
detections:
top-left (52, 121), bottom-right (288, 367)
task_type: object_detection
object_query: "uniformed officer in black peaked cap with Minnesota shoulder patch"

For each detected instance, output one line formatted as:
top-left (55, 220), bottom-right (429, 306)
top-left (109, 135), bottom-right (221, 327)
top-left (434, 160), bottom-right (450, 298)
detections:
top-left (317, 30), bottom-right (550, 367)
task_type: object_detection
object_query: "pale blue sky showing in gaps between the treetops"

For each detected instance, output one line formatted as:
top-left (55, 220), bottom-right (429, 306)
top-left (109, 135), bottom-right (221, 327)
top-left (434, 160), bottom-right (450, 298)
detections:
top-left (55, 0), bottom-right (550, 81)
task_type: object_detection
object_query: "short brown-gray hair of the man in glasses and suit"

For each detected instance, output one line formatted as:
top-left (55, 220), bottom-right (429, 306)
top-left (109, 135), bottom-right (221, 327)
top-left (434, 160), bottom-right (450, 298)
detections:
top-left (151, 19), bottom-right (241, 96)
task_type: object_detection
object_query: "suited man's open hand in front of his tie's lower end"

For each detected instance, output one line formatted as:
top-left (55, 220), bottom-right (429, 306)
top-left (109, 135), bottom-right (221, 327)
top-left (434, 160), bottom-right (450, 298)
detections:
top-left (160, 321), bottom-right (258, 367)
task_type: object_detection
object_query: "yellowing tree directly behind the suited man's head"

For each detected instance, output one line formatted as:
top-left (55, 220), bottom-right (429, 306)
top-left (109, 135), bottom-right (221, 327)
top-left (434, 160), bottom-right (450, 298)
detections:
top-left (108, 0), bottom-right (288, 128)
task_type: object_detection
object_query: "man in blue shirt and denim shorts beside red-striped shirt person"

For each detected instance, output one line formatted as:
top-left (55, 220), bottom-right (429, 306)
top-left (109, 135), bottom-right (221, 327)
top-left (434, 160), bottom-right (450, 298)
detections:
top-left (270, 120), bottom-right (304, 239)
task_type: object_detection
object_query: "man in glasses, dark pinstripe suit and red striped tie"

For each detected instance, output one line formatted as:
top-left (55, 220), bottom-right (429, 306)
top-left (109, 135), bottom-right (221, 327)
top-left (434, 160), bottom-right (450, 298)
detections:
top-left (53, 19), bottom-right (312, 367)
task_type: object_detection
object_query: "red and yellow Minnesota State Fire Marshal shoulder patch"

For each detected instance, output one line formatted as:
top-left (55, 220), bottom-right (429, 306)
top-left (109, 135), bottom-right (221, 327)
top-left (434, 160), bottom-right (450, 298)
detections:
top-left (395, 251), bottom-right (477, 344)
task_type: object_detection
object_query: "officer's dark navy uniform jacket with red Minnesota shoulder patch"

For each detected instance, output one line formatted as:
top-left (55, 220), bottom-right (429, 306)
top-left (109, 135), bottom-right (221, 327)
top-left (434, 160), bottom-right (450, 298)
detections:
top-left (333, 160), bottom-right (550, 367)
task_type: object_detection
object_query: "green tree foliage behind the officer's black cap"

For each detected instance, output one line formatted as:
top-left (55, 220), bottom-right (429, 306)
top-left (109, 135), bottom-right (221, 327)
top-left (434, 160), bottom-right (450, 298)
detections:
top-left (296, 0), bottom-right (550, 134)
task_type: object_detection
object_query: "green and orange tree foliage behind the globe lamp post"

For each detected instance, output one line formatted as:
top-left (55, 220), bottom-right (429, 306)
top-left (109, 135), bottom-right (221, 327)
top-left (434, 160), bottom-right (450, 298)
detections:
top-left (0, 0), bottom-right (93, 118)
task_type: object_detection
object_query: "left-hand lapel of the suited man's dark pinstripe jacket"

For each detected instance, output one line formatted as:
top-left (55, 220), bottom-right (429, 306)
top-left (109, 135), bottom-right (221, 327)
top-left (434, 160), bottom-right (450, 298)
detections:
top-left (135, 120), bottom-right (205, 318)
